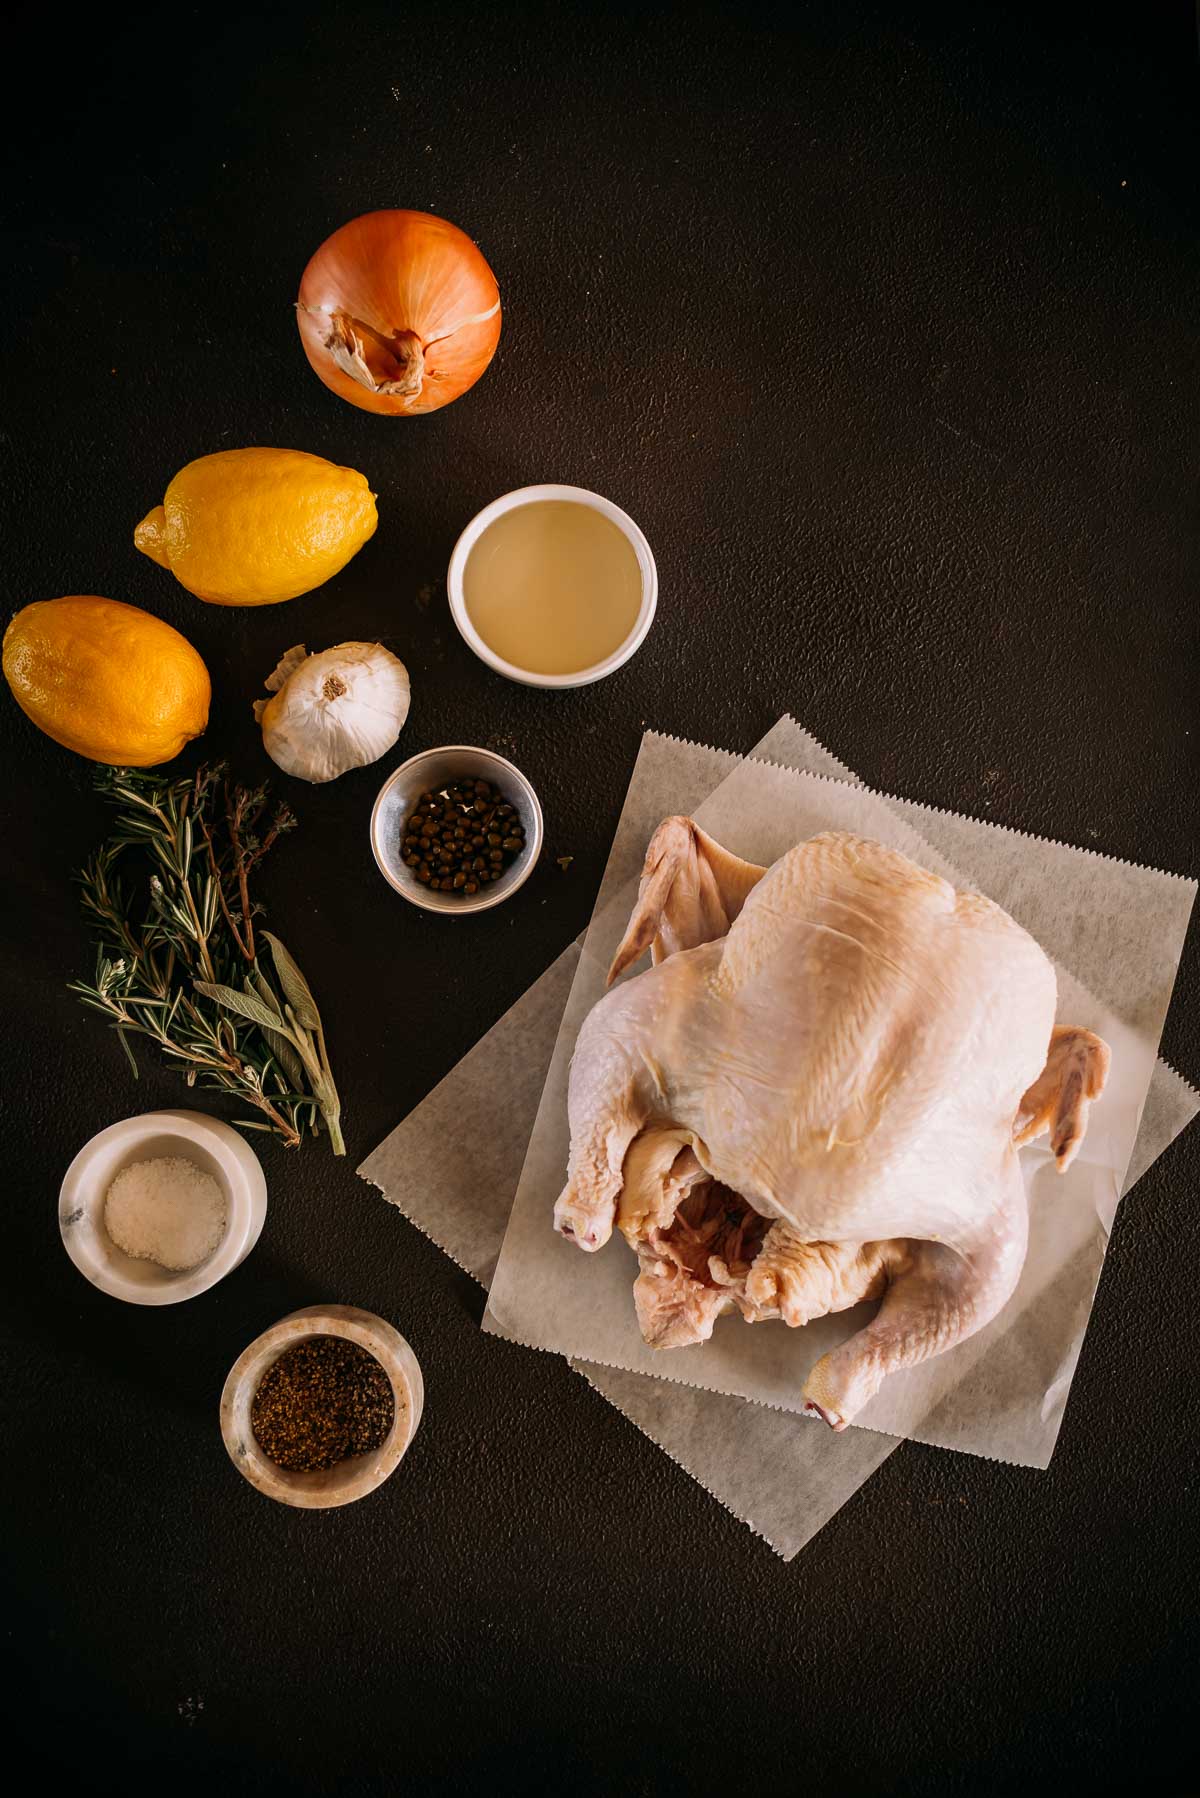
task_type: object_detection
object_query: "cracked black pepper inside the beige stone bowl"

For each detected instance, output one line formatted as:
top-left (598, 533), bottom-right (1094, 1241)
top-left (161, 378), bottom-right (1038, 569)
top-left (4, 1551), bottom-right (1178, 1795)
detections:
top-left (250, 1336), bottom-right (396, 1473)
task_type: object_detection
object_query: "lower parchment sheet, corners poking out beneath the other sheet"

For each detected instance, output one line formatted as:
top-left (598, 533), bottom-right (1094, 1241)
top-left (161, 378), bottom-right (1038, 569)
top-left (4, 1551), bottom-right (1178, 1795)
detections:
top-left (360, 717), bottom-right (1200, 1559)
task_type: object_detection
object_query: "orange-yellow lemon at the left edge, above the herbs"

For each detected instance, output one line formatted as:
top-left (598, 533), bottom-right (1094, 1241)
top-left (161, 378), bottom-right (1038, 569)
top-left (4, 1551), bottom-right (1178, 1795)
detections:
top-left (4, 593), bottom-right (212, 768)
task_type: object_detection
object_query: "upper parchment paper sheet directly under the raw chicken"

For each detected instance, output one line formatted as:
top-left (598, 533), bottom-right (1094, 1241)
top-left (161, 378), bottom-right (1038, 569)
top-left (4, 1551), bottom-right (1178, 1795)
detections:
top-left (484, 743), bottom-right (1195, 1467)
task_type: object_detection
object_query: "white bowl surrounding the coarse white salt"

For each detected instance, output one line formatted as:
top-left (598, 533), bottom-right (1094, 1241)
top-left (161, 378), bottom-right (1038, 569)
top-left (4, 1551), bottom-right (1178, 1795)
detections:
top-left (58, 1111), bottom-right (266, 1305)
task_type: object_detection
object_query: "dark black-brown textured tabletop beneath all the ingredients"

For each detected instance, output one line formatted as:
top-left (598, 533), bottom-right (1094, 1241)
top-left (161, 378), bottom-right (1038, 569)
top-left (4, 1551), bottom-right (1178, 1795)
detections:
top-left (0, 4), bottom-right (1200, 1794)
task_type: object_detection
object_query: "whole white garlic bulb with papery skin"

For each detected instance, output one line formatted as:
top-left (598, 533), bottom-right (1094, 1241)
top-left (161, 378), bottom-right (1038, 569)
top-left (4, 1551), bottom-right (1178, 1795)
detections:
top-left (254, 644), bottom-right (408, 784)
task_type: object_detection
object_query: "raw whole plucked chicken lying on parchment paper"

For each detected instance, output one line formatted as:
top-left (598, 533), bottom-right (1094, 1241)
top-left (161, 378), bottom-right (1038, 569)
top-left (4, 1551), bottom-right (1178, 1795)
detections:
top-left (554, 818), bottom-right (1108, 1429)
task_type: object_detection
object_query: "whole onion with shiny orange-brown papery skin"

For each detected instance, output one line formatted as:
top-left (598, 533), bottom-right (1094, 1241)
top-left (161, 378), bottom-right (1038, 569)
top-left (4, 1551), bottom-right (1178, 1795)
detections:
top-left (295, 209), bottom-right (500, 417)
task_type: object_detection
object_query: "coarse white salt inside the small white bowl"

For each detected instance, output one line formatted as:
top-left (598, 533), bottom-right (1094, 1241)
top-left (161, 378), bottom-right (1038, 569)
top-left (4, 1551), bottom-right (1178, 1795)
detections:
top-left (104, 1154), bottom-right (227, 1273)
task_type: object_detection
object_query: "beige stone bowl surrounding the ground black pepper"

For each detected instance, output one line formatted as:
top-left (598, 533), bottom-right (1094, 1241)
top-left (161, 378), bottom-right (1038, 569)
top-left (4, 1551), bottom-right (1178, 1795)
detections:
top-left (221, 1305), bottom-right (425, 1510)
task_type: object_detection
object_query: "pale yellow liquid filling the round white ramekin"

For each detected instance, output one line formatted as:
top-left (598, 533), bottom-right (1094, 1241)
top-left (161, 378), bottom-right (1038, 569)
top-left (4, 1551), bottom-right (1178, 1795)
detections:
top-left (462, 500), bottom-right (642, 674)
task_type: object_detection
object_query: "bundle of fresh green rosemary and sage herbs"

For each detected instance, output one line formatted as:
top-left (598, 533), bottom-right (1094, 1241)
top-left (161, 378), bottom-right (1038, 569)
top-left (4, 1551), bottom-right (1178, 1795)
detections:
top-left (70, 762), bottom-right (345, 1154)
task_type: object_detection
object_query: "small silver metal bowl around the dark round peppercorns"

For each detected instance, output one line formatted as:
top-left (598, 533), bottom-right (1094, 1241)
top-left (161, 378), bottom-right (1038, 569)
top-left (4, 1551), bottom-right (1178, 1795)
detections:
top-left (371, 743), bottom-right (542, 917)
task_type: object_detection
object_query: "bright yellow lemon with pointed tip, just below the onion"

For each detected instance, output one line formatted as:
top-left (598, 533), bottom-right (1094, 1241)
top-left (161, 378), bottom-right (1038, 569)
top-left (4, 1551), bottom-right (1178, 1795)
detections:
top-left (133, 450), bottom-right (378, 606)
